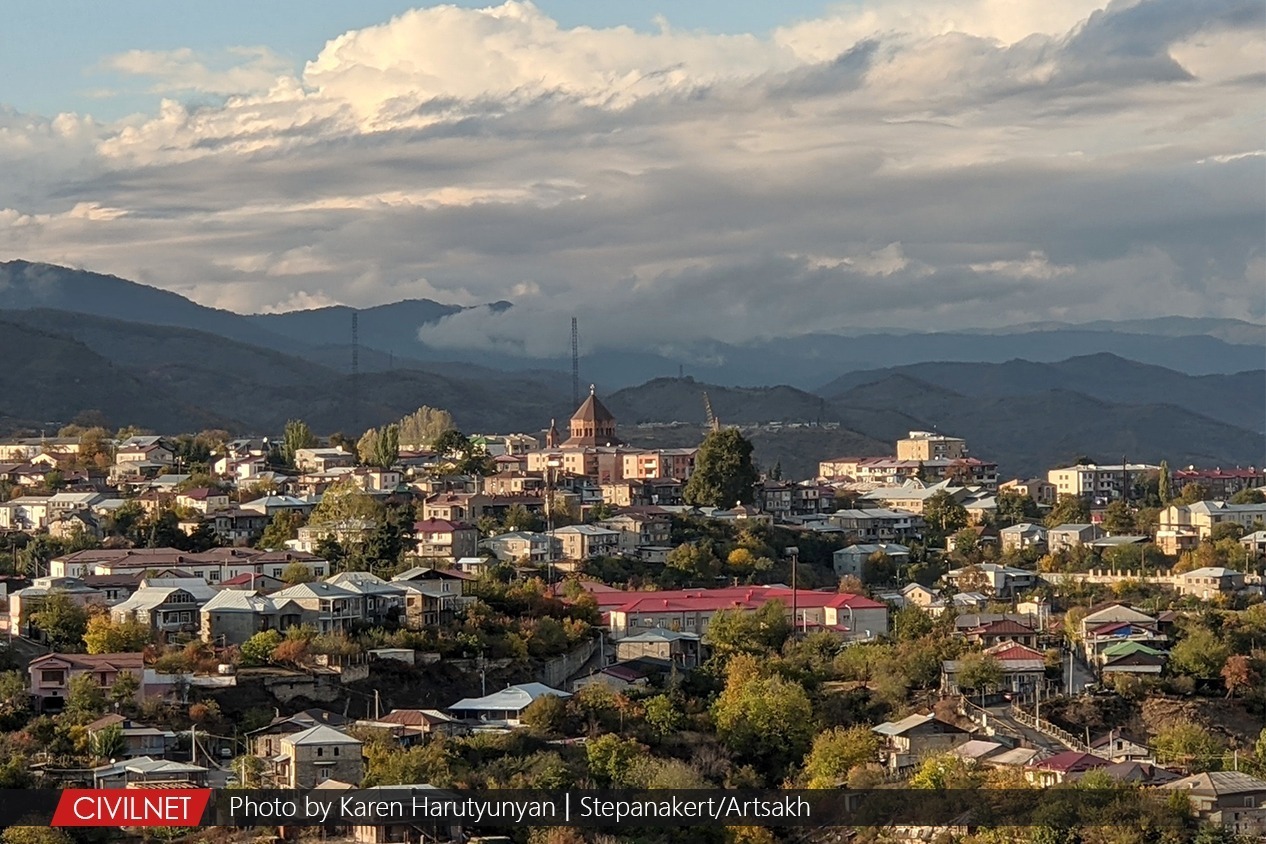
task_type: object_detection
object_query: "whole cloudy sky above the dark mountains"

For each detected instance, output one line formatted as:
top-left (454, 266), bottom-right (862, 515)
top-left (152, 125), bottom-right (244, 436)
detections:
top-left (0, 0), bottom-right (1266, 356)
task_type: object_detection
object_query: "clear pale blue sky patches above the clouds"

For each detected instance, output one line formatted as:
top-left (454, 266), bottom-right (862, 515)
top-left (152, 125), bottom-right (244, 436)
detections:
top-left (0, 0), bottom-right (842, 119)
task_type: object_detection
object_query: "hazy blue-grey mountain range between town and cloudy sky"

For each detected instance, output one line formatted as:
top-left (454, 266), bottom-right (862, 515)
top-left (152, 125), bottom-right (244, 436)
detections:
top-left (0, 262), bottom-right (1266, 476)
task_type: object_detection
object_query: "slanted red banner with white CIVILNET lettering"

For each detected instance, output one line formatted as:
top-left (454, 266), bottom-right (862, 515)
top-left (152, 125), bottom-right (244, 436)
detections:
top-left (52, 788), bottom-right (211, 826)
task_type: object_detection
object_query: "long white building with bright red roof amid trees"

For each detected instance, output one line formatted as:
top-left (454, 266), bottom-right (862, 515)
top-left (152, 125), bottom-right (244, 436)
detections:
top-left (605, 586), bottom-right (887, 639)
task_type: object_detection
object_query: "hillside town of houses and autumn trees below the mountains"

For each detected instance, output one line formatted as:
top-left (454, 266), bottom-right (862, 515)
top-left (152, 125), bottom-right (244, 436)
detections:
top-left (0, 388), bottom-right (1266, 841)
